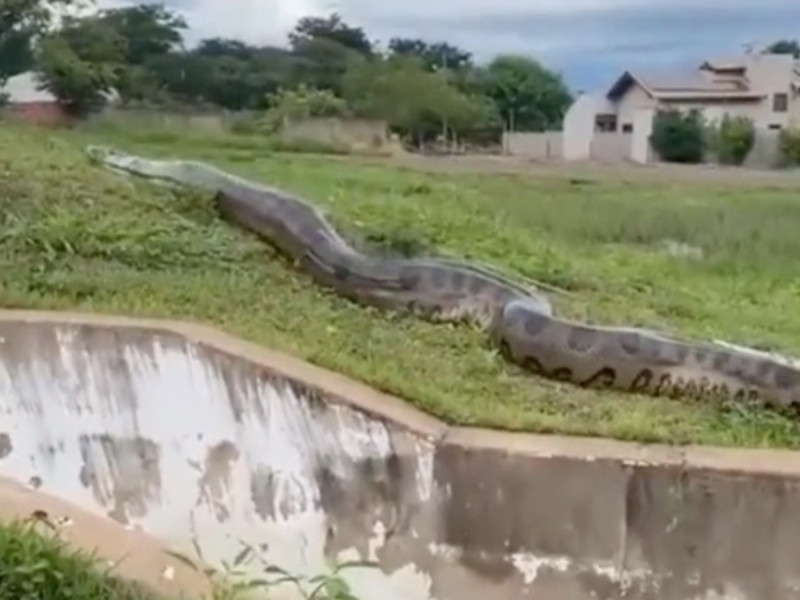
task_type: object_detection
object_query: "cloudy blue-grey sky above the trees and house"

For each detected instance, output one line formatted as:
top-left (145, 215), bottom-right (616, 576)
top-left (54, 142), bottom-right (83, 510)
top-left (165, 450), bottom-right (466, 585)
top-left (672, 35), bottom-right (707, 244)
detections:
top-left (100, 0), bottom-right (800, 90)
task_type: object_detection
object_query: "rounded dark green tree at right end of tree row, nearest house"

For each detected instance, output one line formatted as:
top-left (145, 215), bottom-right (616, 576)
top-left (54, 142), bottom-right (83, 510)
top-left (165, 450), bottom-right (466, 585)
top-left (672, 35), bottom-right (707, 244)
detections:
top-left (483, 55), bottom-right (572, 131)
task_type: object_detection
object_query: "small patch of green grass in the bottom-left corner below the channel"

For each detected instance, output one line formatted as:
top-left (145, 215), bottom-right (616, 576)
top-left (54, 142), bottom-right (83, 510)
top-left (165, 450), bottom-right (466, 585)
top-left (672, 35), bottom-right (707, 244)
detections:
top-left (0, 521), bottom-right (164, 600)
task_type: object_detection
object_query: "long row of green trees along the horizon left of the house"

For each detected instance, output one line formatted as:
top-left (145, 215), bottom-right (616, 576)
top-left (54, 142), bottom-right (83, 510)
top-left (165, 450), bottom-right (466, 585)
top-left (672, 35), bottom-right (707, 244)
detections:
top-left (0, 0), bottom-right (571, 140)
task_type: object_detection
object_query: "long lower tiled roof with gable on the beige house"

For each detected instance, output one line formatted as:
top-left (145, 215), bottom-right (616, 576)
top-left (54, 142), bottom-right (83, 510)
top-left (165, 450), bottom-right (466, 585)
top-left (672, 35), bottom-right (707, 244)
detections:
top-left (606, 71), bottom-right (764, 100)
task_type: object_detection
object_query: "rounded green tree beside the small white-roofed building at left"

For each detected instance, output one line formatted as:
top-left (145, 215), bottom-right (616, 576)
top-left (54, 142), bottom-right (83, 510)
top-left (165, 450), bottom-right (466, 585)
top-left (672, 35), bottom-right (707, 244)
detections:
top-left (36, 18), bottom-right (125, 116)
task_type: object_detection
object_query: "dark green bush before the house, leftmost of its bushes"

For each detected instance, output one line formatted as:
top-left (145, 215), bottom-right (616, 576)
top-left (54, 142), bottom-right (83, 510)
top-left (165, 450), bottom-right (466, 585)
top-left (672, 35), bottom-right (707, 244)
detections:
top-left (650, 109), bottom-right (706, 163)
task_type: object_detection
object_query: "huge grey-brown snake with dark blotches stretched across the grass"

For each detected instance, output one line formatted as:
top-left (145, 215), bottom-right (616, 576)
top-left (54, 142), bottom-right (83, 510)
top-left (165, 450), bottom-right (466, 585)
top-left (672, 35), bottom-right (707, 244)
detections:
top-left (87, 146), bottom-right (800, 409)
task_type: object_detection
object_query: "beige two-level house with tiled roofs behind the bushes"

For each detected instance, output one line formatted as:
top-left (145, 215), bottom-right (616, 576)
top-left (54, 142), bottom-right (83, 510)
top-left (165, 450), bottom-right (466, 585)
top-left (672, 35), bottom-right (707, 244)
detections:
top-left (563, 54), bottom-right (800, 160)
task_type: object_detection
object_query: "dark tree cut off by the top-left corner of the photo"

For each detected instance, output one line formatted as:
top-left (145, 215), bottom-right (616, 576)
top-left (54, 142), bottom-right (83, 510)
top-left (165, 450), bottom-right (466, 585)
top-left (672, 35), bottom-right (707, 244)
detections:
top-left (0, 0), bottom-right (78, 85)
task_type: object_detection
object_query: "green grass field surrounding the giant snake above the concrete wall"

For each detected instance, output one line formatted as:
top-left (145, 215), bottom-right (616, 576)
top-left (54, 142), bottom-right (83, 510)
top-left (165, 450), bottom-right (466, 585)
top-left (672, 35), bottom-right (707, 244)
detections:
top-left (0, 120), bottom-right (800, 447)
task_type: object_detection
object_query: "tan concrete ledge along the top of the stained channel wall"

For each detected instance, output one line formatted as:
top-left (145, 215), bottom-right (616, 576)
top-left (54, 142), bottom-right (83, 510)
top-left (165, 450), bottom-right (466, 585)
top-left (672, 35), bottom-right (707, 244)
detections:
top-left (0, 309), bottom-right (800, 477)
